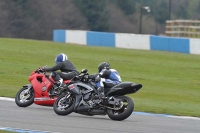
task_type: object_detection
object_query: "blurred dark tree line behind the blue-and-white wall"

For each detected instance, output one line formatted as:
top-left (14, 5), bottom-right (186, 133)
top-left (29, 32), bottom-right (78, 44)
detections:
top-left (0, 0), bottom-right (200, 40)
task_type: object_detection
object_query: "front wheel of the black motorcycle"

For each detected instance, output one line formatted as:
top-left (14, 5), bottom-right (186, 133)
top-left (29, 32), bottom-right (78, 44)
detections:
top-left (53, 95), bottom-right (75, 115)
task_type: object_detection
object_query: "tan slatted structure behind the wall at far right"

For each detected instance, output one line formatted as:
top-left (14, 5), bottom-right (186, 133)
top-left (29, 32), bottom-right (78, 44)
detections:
top-left (165, 20), bottom-right (200, 38)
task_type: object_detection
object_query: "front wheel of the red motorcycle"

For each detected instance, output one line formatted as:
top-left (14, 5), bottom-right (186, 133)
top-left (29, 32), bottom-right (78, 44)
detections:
top-left (15, 87), bottom-right (34, 107)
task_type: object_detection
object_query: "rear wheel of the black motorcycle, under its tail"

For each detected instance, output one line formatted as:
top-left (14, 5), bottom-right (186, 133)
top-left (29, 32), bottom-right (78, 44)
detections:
top-left (107, 96), bottom-right (134, 121)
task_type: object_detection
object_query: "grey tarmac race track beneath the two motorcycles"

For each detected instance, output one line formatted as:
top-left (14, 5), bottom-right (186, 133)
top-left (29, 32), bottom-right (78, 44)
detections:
top-left (0, 100), bottom-right (200, 133)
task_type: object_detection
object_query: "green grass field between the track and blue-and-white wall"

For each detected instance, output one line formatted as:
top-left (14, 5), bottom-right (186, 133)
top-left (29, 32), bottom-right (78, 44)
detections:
top-left (0, 38), bottom-right (200, 117)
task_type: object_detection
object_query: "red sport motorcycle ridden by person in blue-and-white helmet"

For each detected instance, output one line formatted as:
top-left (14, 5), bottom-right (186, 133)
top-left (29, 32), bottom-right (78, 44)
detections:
top-left (15, 68), bottom-right (70, 107)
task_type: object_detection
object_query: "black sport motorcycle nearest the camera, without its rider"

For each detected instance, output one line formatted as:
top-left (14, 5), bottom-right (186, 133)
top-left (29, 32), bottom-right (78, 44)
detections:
top-left (53, 69), bottom-right (142, 121)
